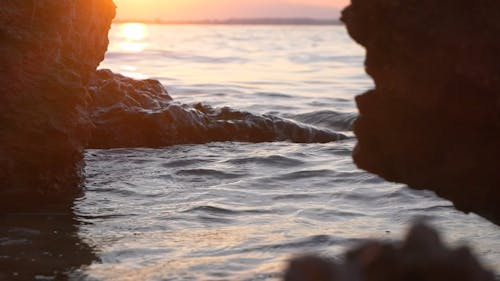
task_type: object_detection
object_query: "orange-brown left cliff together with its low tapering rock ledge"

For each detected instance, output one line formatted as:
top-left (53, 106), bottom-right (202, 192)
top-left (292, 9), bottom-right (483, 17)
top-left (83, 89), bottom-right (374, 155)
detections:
top-left (0, 0), bottom-right (345, 211)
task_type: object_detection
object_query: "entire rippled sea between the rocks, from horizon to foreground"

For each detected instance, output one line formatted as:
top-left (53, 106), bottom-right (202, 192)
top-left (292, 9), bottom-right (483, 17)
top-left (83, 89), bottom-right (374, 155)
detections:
top-left (38, 23), bottom-right (500, 281)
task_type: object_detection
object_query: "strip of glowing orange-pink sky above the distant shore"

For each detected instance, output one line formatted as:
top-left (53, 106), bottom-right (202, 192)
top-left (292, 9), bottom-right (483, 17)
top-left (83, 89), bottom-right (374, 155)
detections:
top-left (115, 0), bottom-right (349, 20)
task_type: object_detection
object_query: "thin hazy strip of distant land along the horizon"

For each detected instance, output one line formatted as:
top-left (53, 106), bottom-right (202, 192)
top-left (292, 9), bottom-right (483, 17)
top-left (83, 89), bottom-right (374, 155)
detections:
top-left (113, 18), bottom-right (343, 25)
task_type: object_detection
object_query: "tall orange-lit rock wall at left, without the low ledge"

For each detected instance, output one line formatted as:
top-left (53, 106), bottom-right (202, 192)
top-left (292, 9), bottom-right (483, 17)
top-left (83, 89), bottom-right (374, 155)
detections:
top-left (0, 0), bottom-right (115, 209)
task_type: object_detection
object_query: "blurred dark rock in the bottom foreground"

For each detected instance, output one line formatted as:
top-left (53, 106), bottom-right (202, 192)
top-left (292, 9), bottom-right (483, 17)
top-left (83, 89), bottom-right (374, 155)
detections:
top-left (284, 224), bottom-right (496, 281)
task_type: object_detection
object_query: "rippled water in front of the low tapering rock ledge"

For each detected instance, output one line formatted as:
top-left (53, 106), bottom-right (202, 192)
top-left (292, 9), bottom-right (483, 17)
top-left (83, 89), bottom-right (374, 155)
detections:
top-left (76, 140), bottom-right (500, 280)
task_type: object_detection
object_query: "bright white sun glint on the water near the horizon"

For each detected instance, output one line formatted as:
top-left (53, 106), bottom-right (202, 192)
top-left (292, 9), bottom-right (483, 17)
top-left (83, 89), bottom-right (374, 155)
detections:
top-left (119, 23), bottom-right (149, 53)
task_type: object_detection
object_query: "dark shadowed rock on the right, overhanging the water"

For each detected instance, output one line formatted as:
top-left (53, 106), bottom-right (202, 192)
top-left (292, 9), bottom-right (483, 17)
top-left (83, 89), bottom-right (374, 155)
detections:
top-left (342, 0), bottom-right (500, 224)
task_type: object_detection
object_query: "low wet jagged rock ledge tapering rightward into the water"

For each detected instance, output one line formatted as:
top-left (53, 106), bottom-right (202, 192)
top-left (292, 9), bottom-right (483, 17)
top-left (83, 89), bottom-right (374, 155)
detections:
top-left (88, 70), bottom-right (345, 148)
